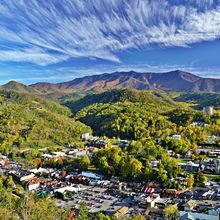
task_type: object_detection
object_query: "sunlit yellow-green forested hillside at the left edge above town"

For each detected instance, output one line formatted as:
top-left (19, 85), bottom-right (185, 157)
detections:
top-left (0, 91), bottom-right (90, 153)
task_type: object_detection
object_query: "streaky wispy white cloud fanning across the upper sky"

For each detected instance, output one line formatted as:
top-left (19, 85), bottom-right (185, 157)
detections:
top-left (0, 0), bottom-right (220, 65)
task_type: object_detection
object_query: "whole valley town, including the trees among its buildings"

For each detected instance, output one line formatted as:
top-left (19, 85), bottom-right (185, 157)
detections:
top-left (0, 130), bottom-right (220, 220)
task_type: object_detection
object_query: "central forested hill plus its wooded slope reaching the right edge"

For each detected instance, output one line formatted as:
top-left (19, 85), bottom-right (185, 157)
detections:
top-left (66, 89), bottom-right (219, 151)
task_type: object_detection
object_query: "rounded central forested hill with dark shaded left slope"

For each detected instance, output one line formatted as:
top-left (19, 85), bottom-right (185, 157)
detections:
top-left (66, 89), bottom-right (183, 139)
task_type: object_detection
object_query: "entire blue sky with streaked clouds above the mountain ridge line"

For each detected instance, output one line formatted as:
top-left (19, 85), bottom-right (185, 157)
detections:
top-left (0, 0), bottom-right (220, 84)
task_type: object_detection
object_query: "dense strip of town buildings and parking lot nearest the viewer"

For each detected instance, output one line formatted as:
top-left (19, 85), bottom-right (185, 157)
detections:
top-left (0, 151), bottom-right (220, 220)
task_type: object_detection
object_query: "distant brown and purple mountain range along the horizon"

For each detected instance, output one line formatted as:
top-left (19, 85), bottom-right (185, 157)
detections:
top-left (2, 70), bottom-right (220, 94)
